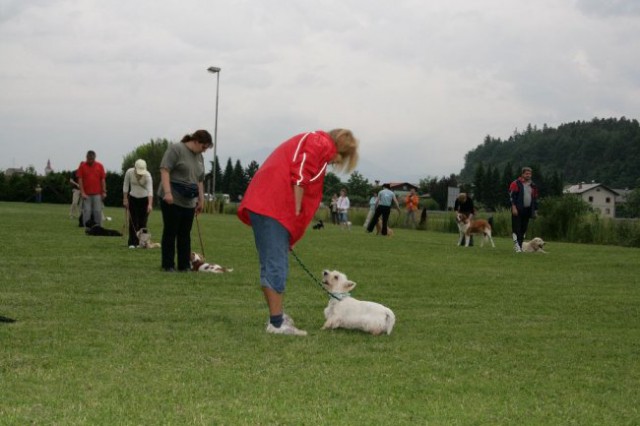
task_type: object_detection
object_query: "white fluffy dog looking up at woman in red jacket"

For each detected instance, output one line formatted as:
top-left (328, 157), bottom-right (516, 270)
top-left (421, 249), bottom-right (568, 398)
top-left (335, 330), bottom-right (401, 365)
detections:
top-left (322, 270), bottom-right (396, 335)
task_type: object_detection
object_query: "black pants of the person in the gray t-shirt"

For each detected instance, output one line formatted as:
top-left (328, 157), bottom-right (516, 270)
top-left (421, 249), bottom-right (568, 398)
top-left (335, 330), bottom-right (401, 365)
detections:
top-left (160, 201), bottom-right (196, 271)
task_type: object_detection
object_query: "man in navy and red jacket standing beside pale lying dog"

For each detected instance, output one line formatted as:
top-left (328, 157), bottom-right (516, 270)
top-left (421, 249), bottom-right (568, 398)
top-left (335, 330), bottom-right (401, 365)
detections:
top-left (509, 167), bottom-right (538, 253)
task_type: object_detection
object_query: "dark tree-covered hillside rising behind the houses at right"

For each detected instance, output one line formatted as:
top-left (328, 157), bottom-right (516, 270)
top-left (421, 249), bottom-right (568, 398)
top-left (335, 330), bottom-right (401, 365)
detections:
top-left (460, 117), bottom-right (640, 188)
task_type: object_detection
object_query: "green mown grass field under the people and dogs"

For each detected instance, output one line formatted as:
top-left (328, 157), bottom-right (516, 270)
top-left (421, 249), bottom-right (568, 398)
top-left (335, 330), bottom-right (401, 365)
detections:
top-left (0, 203), bottom-right (640, 425)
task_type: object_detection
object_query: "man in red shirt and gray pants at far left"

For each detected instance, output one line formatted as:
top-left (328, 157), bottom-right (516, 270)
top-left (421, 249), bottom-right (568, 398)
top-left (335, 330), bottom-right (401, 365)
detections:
top-left (77, 151), bottom-right (107, 227)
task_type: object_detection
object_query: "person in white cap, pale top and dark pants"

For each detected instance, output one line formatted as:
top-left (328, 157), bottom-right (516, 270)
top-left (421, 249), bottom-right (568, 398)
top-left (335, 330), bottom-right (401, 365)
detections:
top-left (122, 159), bottom-right (153, 248)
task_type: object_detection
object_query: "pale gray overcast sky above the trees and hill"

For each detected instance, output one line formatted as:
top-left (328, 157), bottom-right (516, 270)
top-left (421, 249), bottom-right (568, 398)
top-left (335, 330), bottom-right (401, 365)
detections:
top-left (0, 0), bottom-right (640, 182)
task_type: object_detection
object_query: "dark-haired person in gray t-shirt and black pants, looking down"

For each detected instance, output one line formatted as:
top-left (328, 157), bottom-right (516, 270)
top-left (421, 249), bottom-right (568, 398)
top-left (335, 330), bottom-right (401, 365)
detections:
top-left (158, 130), bottom-right (213, 272)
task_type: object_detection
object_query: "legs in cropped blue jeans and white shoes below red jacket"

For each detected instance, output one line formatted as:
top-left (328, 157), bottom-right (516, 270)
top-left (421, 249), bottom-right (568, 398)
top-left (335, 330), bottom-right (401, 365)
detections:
top-left (250, 213), bottom-right (307, 336)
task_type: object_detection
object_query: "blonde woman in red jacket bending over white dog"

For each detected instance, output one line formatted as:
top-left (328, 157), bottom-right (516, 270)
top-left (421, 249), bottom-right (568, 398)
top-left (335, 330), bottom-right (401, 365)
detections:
top-left (238, 129), bottom-right (358, 336)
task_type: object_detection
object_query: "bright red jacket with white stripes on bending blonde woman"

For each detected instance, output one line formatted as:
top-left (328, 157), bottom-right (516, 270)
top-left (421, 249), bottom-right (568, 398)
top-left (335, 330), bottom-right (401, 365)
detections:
top-left (238, 130), bottom-right (337, 247)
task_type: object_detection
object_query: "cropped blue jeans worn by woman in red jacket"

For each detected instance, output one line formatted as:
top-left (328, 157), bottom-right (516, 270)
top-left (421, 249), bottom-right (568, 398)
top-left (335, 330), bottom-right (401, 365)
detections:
top-left (249, 212), bottom-right (289, 294)
